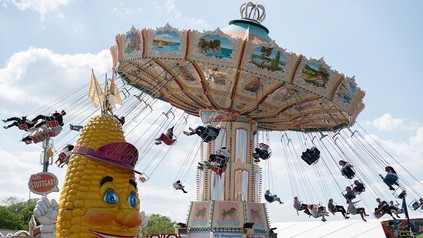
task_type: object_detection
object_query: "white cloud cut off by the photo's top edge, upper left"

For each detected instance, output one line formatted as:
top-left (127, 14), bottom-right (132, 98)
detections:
top-left (10, 0), bottom-right (71, 22)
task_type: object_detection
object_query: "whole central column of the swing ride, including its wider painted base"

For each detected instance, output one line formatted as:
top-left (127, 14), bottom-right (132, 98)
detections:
top-left (187, 110), bottom-right (269, 238)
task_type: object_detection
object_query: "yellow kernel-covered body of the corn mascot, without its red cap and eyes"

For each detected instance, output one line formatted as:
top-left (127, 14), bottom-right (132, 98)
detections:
top-left (56, 115), bottom-right (140, 238)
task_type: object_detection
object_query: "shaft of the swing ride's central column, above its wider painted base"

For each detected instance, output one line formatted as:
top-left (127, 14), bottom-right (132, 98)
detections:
top-left (198, 110), bottom-right (261, 202)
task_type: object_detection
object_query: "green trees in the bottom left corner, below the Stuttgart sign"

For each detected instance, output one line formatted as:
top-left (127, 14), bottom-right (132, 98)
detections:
top-left (0, 197), bottom-right (38, 230)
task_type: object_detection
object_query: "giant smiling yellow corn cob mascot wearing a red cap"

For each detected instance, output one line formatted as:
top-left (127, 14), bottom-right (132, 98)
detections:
top-left (56, 114), bottom-right (142, 238)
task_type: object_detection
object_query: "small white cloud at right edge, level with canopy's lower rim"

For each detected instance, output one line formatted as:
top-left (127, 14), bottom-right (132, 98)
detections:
top-left (364, 113), bottom-right (420, 131)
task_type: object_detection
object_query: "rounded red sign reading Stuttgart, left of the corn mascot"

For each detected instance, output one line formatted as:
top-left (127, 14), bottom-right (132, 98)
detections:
top-left (28, 172), bottom-right (59, 195)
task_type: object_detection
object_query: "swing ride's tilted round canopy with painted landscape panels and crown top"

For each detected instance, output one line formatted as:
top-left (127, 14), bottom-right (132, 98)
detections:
top-left (111, 2), bottom-right (365, 131)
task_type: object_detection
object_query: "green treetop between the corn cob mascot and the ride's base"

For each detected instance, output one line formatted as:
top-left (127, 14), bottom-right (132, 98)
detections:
top-left (142, 214), bottom-right (176, 237)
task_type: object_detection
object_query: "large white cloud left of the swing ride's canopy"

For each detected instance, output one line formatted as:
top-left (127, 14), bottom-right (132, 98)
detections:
top-left (0, 48), bottom-right (112, 112)
